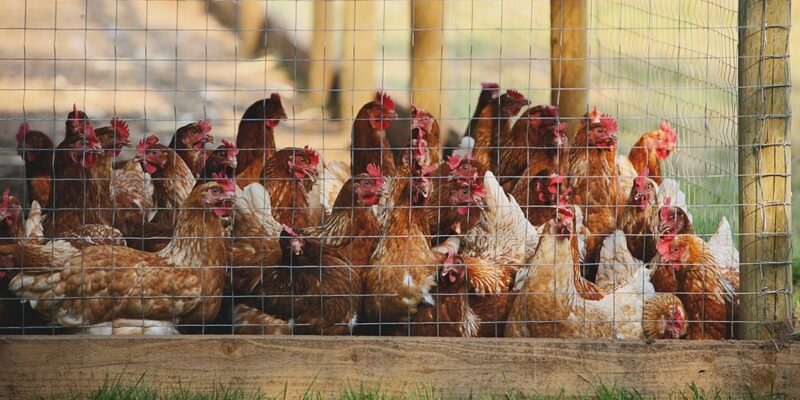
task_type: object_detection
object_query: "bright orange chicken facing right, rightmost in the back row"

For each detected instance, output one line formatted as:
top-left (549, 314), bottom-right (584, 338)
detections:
top-left (628, 122), bottom-right (678, 185)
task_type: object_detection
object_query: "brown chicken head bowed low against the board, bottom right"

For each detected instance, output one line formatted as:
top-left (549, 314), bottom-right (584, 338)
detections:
top-left (642, 293), bottom-right (686, 339)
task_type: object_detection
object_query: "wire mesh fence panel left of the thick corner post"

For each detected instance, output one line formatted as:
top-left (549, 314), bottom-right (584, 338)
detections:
top-left (0, 0), bottom-right (792, 339)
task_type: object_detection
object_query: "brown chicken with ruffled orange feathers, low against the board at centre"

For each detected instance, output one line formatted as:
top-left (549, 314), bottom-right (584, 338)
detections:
top-left (411, 252), bottom-right (515, 337)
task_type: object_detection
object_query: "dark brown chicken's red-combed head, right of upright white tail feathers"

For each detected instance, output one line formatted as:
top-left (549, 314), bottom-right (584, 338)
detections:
top-left (511, 168), bottom-right (566, 226)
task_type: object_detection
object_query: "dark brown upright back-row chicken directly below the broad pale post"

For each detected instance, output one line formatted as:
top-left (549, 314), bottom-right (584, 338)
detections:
top-left (350, 92), bottom-right (397, 176)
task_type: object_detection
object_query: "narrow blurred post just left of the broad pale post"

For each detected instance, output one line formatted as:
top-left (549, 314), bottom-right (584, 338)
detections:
top-left (308, 0), bottom-right (336, 107)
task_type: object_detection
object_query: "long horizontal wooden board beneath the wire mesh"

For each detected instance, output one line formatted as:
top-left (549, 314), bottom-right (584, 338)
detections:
top-left (0, 336), bottom-right (800, 398)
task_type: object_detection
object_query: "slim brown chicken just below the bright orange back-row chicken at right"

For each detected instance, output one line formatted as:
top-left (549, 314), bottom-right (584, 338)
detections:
top-left (618, 168), bottom-right (659, 262)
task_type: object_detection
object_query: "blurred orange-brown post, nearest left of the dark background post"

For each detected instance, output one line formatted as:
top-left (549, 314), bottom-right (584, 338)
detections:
top-left (411, 0), bottom-right (447, 126)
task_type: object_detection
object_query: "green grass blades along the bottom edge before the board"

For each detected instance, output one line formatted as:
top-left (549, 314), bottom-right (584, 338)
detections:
top-left (53, 377), bottom-right (776, 400)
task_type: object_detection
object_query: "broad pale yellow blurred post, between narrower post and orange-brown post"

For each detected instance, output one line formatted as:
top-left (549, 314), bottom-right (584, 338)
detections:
top-left (339, 0), bottom-right (380, 126)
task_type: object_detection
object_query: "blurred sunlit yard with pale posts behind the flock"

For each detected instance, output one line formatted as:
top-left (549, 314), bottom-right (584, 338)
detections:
top-left (0, 0), bottom-right (800, 306)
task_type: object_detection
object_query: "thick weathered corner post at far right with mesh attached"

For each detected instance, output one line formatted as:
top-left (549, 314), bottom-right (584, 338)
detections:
top-left (737, 0), bottom-right (792, 339)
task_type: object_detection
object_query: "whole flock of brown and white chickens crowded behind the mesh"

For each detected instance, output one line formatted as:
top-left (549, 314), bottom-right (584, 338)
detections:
top-left (0, 83), bottom-right (738, 339)
